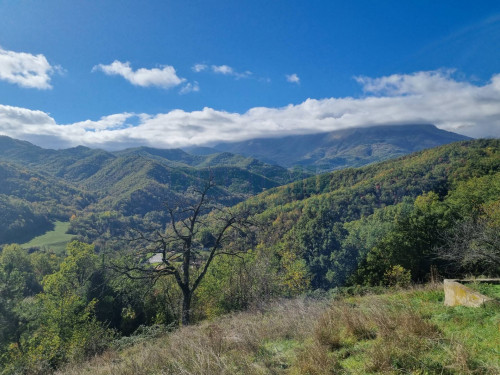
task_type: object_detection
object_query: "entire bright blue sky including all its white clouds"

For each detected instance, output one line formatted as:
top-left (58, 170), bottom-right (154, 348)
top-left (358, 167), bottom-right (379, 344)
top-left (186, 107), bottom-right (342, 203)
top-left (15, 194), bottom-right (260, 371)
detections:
top-left (0, 0), bottom-right (500, 148)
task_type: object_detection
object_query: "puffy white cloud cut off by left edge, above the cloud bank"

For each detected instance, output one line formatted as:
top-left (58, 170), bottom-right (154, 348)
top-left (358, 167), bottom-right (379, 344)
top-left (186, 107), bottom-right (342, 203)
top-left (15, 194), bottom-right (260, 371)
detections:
top-left (0, 47), bottom-right (62, 90)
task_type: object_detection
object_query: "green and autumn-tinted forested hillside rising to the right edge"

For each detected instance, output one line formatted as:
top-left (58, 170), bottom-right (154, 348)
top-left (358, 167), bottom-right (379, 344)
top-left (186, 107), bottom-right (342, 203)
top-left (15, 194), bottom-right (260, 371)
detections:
top-left (231, 140), bottom-right (500, 289)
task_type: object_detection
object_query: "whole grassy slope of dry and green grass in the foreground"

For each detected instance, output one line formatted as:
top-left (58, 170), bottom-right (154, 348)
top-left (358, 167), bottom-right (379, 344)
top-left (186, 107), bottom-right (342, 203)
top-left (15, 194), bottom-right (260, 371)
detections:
top-left (56, 287), bottom-right (500, 375)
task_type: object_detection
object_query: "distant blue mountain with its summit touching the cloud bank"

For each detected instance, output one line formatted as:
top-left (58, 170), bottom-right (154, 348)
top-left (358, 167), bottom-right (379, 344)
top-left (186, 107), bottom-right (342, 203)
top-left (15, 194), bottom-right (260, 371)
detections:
top-left (213, 124), bottom-right (471, 172)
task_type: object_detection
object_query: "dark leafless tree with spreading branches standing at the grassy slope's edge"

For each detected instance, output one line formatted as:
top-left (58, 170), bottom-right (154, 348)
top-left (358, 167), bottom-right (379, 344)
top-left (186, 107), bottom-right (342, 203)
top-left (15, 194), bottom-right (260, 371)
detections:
top-left (112, 176), bottom-right (254, 325)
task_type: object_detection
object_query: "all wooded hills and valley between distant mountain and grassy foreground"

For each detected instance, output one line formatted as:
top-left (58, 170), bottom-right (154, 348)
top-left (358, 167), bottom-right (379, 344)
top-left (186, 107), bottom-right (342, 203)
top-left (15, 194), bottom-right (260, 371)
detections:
top-left (0, 139), bottom-right (500, 374)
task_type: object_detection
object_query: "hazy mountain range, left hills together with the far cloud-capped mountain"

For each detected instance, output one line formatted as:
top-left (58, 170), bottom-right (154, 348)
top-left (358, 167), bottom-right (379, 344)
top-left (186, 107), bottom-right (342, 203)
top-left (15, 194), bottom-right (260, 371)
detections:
top-left (0, 125), bottom-right (467, 244)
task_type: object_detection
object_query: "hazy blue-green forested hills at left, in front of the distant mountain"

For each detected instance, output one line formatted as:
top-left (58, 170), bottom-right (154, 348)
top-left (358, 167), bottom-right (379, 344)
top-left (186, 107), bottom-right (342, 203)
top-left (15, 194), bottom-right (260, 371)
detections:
top-left (0, 136), bottom-right (309, 244)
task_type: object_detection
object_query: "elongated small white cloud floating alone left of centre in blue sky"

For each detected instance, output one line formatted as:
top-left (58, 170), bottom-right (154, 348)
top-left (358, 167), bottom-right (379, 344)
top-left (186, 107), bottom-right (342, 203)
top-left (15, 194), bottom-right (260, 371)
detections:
top-left (92, 60), bottom-right (186, 89)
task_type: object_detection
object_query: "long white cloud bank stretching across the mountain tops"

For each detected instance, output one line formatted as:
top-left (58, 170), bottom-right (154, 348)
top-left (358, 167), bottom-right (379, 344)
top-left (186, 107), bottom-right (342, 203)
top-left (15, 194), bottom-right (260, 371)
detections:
top-left (0, 71), bottom-right (500, 149)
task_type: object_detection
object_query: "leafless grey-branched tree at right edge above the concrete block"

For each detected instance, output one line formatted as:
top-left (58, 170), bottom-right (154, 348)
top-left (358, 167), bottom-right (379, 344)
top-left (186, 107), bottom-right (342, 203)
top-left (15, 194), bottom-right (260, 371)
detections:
top-left (438, 218), bottom-right (500, 274)
